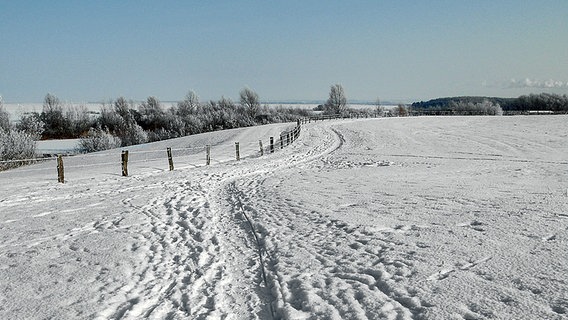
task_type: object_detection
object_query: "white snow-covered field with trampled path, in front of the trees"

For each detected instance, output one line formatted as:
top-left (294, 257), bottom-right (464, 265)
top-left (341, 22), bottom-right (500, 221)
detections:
top-left (0, 116), bottom-right (568, 319)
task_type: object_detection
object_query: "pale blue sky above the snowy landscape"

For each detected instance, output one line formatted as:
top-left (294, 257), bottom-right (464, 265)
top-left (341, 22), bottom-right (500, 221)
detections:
top-left (0, 0), bottom-right (568, 102)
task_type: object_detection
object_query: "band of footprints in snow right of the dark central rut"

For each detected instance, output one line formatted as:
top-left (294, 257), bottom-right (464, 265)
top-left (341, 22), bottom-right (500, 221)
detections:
top-left (229, 179), bottom-right (428, 319)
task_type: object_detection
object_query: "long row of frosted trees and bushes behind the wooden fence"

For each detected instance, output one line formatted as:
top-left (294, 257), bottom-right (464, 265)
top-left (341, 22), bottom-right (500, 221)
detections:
top-left (0, 88), bottom-right (312, 159)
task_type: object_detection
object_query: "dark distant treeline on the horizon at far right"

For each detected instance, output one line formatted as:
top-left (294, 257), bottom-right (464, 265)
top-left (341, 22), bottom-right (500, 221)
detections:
top-left (412, 93), bottom-right (568, 114)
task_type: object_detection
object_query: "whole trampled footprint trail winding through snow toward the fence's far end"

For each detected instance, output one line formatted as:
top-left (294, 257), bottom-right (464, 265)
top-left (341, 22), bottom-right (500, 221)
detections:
top-left (92, 122), bottom-right (382, 319)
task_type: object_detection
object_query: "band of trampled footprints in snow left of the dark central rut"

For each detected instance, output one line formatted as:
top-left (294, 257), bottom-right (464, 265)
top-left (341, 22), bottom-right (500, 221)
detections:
top-left (95, 183), bottom-right (221, 319)
